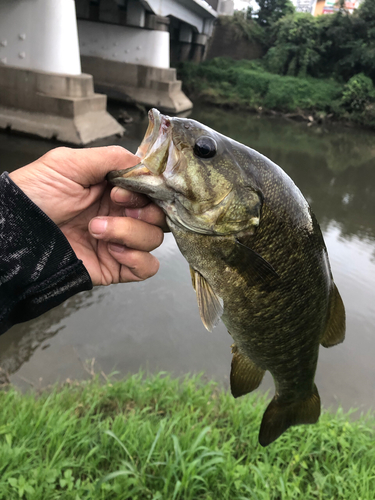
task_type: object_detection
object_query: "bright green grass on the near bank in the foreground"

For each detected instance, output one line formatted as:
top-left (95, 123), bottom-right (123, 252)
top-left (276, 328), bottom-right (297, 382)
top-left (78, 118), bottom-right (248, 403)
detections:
top-left (0, 374), bottom-right (375, 500)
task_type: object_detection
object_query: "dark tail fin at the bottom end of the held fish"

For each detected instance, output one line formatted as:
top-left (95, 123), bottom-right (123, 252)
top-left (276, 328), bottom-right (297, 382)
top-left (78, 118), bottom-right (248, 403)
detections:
top-left (259, 385), bottom-right (320, 446)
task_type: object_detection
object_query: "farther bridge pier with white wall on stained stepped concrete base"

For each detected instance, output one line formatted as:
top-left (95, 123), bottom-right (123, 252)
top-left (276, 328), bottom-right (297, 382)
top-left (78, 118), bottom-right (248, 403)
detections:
top-left (77, 0), bottom-right (193, 113)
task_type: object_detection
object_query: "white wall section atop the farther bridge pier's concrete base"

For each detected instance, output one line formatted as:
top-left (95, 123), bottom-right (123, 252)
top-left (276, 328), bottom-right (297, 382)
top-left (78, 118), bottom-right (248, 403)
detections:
top-left (78, 20), bottom-right (169, 68)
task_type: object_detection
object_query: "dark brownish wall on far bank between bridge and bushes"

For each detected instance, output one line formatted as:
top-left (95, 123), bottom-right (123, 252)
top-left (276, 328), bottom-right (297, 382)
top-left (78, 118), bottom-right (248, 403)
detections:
top-left (205, 24), bottom-right (265, 60)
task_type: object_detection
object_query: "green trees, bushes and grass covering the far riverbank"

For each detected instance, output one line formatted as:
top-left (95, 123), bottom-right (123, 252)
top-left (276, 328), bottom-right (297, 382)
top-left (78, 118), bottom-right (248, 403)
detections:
top-left (178, 0), bottom-right (375, 128)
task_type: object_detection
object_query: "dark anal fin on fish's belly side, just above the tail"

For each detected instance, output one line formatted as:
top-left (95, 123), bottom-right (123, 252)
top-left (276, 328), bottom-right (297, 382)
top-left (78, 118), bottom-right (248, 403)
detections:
top-left (230, 344), bottom-right (264, 398)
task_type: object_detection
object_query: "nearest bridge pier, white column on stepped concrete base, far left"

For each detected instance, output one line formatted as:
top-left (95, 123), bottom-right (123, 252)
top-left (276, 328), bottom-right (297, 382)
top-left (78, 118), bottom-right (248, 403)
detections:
top-left (0, 0), bottom-right (123, 145)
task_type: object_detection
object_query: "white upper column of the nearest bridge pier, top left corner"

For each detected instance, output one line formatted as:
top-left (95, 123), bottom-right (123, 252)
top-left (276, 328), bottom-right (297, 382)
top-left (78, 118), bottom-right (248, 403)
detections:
top-left (0, 0), bottom-right (81, 75)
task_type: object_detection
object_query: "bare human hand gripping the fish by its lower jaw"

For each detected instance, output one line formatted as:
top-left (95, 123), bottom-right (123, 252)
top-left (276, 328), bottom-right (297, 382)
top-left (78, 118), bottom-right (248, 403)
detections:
top-left (9, 146), bottom-right (166, 285)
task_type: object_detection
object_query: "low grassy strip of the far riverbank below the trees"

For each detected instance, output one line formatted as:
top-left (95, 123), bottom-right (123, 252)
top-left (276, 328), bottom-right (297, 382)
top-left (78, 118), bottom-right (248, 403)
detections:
top-left (178, 57), bottom-right (375, 128)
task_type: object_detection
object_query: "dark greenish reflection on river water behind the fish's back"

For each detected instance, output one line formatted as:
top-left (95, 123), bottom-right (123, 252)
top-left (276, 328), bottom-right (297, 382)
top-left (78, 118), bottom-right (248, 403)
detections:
top-left (194, 107), bottom-right (375, 244)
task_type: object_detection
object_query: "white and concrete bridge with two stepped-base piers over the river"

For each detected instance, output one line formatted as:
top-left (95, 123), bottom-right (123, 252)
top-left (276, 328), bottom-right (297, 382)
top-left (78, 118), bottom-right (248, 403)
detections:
top-left (0, 0), bottom-right (219, 144)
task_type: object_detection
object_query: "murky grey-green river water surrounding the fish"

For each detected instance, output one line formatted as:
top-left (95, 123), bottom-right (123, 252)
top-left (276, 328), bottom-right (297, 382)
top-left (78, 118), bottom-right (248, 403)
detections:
top-left (0, 105), bottom-right (375, 411)
